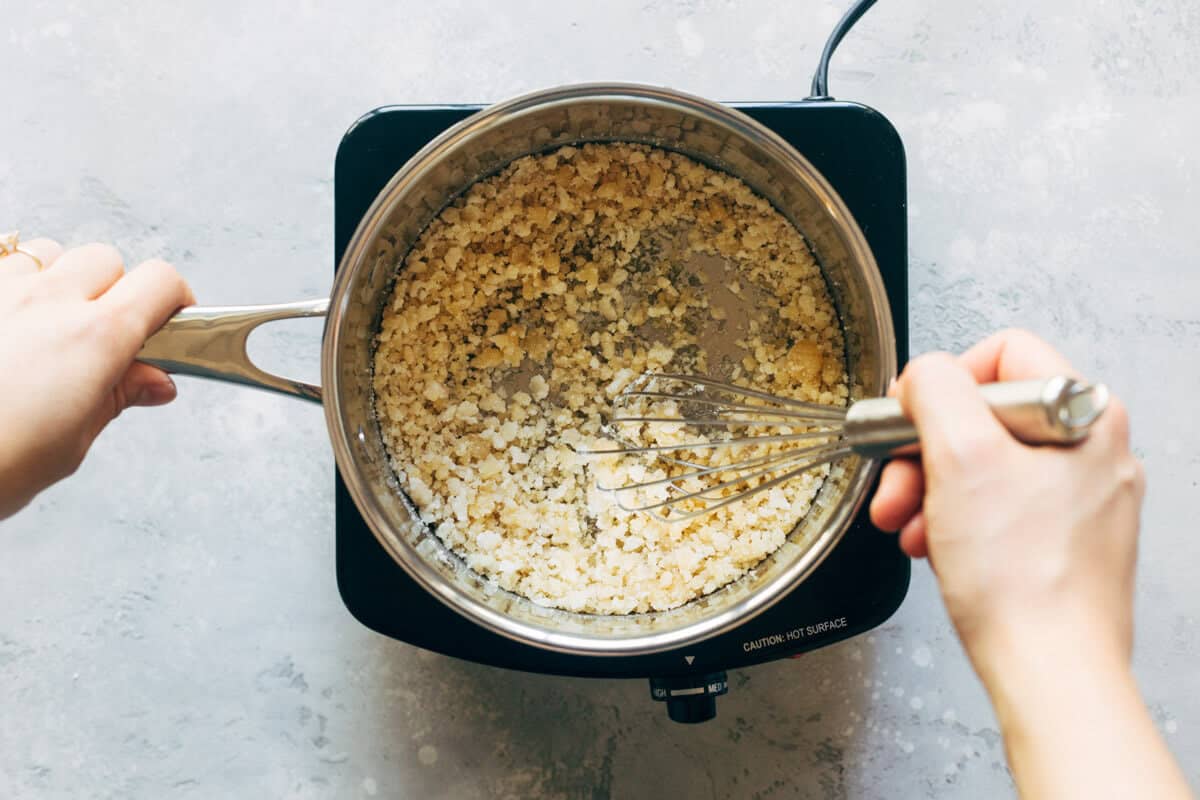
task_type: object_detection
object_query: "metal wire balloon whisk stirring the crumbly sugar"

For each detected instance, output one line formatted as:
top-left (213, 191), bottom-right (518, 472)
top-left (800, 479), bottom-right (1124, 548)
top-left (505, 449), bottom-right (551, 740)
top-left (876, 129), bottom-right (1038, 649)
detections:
top-left (582, 373), bottom-right (1109, 521)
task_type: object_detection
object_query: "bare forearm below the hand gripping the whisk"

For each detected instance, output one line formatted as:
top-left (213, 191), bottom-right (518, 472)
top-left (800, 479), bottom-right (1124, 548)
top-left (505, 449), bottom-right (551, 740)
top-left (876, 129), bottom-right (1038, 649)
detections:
top-left (982, 633), bottom-right (1192, 800)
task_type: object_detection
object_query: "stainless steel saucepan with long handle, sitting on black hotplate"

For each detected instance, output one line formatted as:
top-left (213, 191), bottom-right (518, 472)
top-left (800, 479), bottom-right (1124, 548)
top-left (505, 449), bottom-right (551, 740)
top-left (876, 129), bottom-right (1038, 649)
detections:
top-left (139, 84), bottom-right (896, 656)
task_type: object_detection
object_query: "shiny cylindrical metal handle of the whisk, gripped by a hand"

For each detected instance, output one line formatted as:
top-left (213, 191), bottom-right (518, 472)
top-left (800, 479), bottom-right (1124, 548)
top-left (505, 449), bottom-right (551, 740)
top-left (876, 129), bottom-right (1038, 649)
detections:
top-left (846, 375), bottom-right (1109, 458)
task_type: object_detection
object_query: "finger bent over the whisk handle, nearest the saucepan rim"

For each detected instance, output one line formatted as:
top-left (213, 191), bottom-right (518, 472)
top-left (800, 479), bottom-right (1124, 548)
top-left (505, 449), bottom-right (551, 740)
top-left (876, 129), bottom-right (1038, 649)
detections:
top-left (900, 353), bottom-right (1013, 474)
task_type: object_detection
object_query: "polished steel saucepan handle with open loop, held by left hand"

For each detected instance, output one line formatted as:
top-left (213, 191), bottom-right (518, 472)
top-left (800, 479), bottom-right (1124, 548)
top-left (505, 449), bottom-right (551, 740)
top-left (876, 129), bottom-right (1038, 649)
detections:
top-left (138, 297), bottom-right (329, 403)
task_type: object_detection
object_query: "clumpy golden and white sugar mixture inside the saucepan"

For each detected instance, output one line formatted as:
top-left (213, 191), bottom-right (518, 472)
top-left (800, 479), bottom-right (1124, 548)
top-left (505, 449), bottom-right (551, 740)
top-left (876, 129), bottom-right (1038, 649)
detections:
top-left (374, 143), bottom-right (847, 614)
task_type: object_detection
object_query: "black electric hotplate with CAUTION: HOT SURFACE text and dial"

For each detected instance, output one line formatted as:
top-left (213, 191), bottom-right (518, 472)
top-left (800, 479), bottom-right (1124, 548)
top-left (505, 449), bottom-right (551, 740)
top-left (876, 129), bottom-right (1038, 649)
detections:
top-left (334, 100), bottom-right (910, 721)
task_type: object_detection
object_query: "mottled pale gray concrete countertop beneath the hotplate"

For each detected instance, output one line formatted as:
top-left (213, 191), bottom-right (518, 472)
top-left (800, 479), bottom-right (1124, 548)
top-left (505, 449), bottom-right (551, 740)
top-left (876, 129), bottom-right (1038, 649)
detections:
top-left (0, 0), bottom-right (1200, 800)
